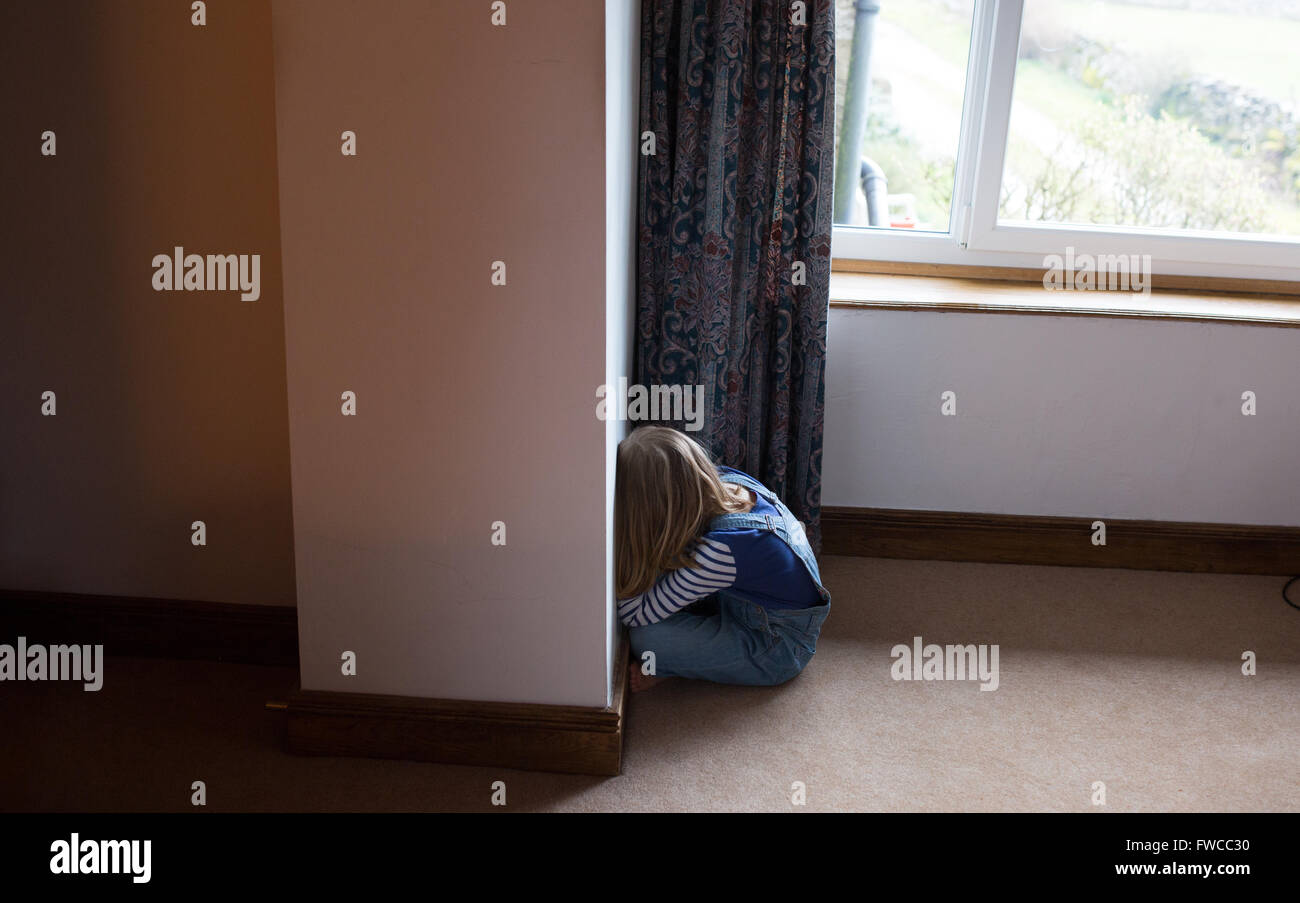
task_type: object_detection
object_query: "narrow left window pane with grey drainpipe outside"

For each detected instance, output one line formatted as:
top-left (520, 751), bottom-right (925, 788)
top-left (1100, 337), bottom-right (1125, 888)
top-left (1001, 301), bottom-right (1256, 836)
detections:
top-left (835, 0), bottom-right (975, 233)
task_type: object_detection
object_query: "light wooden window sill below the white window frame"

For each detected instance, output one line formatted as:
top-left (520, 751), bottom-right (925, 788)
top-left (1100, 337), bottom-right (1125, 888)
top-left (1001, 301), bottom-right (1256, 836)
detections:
top-left (831, 270), bottom-right (1300, 327)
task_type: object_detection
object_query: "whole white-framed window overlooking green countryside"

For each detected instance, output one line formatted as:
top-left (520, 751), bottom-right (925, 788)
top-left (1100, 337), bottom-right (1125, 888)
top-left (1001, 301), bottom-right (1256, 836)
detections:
top-left (833, 0), bottom-right (1300, 279)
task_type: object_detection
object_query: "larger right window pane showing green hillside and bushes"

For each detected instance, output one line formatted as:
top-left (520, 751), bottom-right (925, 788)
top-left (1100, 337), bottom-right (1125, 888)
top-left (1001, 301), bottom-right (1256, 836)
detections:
top-left (1000, 0), bottom-right (1300, 236)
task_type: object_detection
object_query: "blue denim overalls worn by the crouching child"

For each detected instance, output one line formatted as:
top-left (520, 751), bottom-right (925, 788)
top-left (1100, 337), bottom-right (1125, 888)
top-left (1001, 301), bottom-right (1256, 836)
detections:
top-left (629, 472), bottom-right (831, 686)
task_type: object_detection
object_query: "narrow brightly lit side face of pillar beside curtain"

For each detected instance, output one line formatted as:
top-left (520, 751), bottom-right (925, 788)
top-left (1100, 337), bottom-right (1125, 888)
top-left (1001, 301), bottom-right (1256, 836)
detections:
top-left (605, 0), bottom-right (641, 702)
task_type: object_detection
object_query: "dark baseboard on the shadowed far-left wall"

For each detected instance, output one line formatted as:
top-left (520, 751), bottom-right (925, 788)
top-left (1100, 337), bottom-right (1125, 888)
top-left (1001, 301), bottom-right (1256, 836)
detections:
top-left (0, 590), bottom-right (298, 668)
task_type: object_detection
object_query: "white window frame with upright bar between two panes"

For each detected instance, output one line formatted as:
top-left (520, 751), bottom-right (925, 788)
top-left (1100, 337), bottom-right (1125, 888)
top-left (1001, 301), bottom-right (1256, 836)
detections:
top-left (831, 0), bottom-right (1300, 282)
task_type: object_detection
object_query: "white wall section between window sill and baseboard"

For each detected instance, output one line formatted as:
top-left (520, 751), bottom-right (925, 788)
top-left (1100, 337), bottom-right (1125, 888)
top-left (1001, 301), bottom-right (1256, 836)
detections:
top-left (822, 308), bottom-right (1300, 525)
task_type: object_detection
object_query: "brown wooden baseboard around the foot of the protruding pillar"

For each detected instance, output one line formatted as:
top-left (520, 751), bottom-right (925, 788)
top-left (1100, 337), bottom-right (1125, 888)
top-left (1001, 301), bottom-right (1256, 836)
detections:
top-left (283, 637), bottom-right (628, 776)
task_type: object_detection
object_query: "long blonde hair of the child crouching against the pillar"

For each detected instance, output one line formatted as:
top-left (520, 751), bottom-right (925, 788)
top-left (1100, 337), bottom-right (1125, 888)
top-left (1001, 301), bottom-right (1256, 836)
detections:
top-left (614, 426), bottom-right (751, 599)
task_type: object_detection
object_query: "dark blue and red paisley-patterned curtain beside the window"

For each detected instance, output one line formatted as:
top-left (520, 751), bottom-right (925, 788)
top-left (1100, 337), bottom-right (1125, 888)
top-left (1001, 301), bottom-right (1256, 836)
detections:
top-left (636, 0), bottom-right (835, 548)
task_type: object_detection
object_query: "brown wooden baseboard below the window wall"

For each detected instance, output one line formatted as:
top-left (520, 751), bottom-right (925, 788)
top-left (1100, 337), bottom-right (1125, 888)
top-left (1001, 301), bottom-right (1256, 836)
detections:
top-left (822, 507), bottom-right (1300, 576)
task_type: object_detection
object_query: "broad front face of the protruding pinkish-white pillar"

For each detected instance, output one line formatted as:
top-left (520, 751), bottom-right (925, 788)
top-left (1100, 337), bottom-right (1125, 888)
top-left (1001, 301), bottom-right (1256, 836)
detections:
top-left (272, 0), bottom-right (610, 707)
